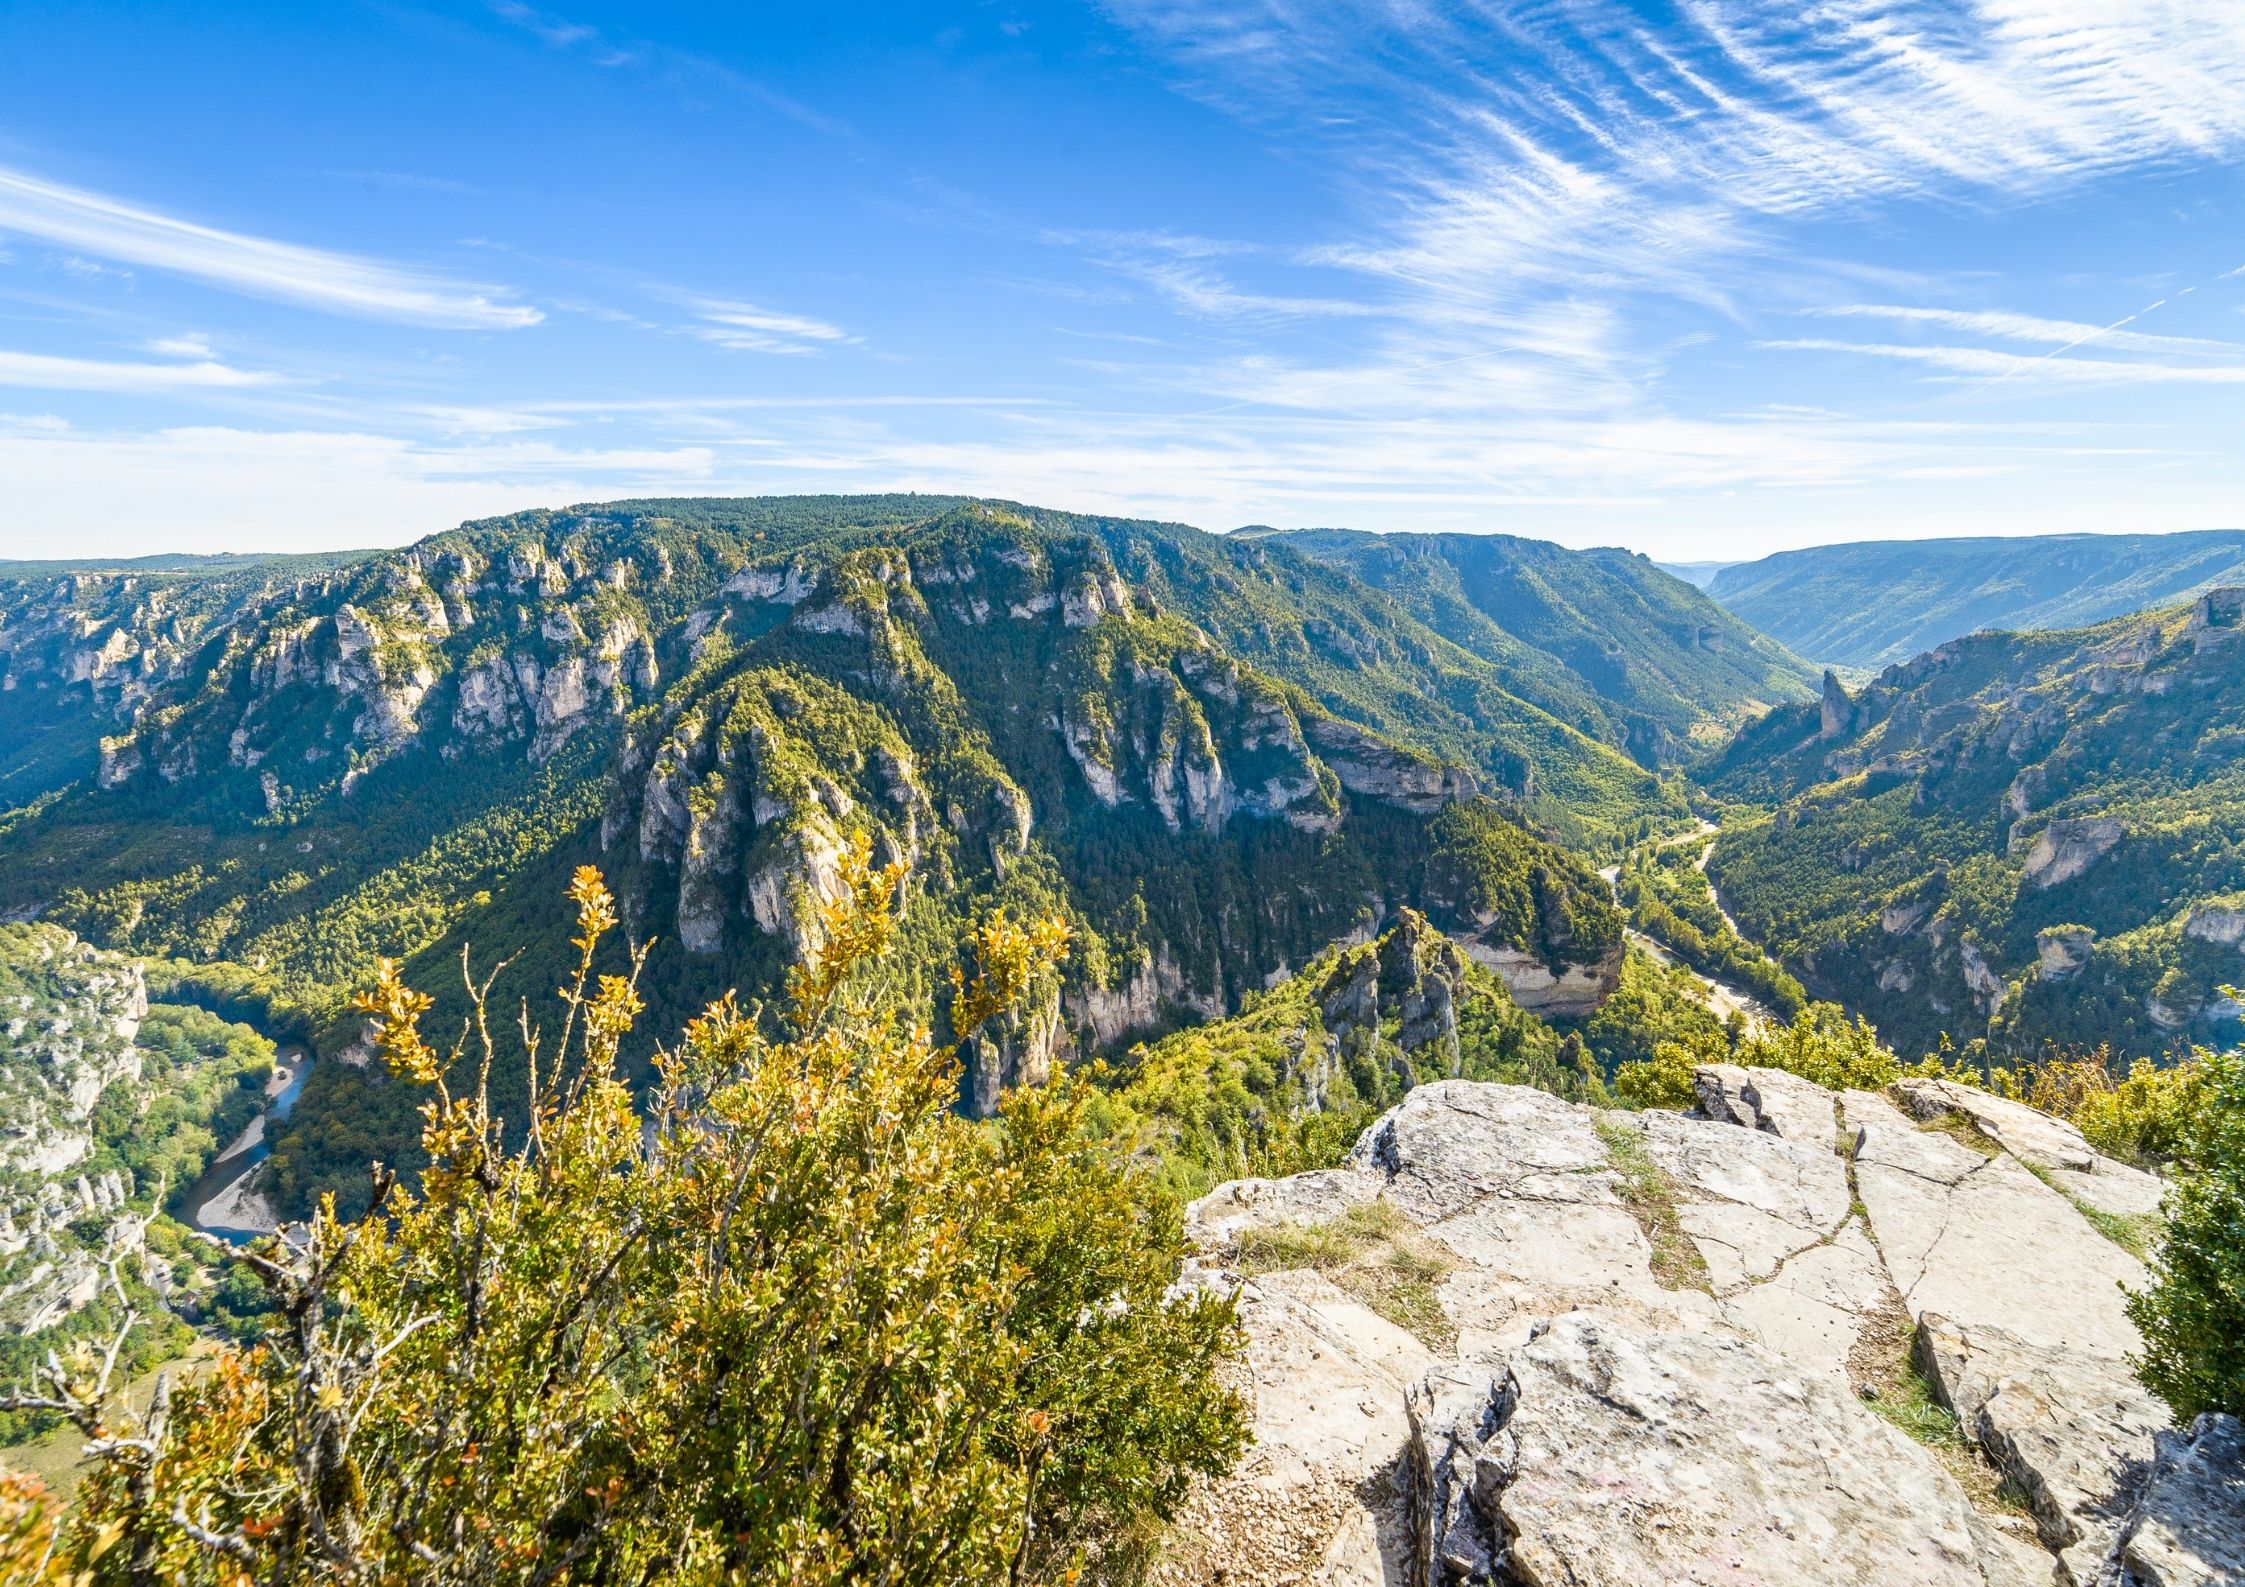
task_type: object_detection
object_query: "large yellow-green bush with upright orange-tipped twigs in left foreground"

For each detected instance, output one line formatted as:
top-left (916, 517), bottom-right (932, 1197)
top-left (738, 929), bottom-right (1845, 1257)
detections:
top-left (0, 848), bottom-right (1241, 1587)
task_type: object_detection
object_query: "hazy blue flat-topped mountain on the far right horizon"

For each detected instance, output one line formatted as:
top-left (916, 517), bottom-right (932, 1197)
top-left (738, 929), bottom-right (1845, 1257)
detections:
top-left (1708, 530), bottom-right (2245, 671)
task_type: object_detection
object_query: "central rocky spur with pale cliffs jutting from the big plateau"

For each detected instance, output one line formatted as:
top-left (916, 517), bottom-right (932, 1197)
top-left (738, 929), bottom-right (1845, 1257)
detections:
top-left (599, 516), bottom-right (1619, 1090)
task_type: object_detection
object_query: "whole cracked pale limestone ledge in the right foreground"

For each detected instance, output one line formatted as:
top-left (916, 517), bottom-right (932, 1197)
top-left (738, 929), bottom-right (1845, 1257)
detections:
top-left (1152, 1064), bottom-right (2245, 1587)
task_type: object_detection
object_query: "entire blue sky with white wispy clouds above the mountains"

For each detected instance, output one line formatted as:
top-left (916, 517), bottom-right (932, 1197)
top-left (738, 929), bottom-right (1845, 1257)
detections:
top-left (0, 0), bottom-right (2245, 559)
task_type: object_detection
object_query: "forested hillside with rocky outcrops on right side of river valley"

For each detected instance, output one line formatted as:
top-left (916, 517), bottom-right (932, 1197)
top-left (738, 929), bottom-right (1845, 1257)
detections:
top-left (1704, 588), bottom-right (2245, 1053)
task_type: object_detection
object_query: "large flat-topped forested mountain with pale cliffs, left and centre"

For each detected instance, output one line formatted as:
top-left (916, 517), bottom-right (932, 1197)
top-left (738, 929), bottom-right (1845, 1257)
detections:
top-left (0, 496), bottom-right (1652, 1205)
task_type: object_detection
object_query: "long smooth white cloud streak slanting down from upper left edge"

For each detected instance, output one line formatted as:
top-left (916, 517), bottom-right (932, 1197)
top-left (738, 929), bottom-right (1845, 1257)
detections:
top-left (0, 166), bottom-right (543, 330)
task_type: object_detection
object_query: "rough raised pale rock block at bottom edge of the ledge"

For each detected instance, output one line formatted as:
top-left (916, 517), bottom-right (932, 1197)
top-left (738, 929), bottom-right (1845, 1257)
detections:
top-left (1410, 1311), bottom-right (1989, 1587)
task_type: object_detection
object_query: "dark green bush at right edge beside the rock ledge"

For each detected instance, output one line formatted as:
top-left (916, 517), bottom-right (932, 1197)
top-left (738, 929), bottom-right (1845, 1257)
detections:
top-left (2128, 1053), bottom-right (2245, 1419)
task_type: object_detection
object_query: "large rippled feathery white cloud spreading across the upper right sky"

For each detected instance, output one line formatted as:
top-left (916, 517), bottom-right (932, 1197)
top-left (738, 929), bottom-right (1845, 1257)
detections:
top-left (1109, 0), bottom-right (2245, 410)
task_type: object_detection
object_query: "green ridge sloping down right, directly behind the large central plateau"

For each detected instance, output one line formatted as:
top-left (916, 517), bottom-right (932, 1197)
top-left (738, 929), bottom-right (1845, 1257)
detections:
top-left (1264, 530), bottom-right (1814, 765)
